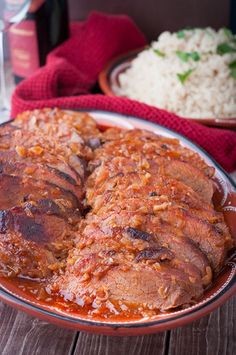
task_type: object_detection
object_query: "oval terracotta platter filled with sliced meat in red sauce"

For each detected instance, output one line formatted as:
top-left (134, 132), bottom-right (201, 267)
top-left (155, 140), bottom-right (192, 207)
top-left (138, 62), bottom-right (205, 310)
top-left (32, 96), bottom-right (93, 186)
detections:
top-left (0, 108), bottom-right (236, 335)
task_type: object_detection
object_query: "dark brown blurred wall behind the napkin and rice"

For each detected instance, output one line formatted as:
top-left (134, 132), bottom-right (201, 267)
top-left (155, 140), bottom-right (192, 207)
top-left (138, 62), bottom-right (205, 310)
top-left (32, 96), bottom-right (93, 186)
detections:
top-left (69, 0), bottom-right (233, 40)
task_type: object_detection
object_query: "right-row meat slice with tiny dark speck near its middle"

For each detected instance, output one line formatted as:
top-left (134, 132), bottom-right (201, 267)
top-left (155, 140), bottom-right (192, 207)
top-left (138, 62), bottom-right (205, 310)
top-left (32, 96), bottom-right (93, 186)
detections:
top-left (86, 168), bottom-right (216, 219)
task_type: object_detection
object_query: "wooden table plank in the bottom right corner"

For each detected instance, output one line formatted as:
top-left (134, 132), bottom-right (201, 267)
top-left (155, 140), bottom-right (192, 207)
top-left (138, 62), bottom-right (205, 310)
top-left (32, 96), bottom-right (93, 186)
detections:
top-left (169, 297), bottom-right (236, 355)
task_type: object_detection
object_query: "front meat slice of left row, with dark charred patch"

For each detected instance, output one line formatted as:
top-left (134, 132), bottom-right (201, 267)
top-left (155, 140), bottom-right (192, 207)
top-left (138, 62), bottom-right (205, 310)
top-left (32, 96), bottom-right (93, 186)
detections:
top-left (0, 206), bottom-right (73, 278)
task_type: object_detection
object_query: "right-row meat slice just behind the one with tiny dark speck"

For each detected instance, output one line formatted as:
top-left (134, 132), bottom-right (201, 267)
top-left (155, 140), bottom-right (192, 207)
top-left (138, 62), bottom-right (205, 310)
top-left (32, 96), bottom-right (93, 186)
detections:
top-left (87, 157), bottom-right (214, 204)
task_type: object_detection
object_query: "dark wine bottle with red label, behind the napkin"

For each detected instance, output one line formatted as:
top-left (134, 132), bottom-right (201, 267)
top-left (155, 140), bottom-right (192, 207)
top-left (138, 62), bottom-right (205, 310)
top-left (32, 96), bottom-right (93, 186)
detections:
top-left (5, 0), bottom-right (69, 83)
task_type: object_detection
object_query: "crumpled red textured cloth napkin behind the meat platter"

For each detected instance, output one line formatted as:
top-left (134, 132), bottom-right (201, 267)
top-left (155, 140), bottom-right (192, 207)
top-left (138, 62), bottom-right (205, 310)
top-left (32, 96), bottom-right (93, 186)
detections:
top-left (11, 13), bottom-right (236, 172)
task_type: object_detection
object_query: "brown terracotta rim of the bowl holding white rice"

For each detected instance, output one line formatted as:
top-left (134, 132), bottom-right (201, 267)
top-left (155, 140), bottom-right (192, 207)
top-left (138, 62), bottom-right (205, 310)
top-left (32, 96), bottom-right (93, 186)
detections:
top-left (98, 45), bottom-right (236, 128)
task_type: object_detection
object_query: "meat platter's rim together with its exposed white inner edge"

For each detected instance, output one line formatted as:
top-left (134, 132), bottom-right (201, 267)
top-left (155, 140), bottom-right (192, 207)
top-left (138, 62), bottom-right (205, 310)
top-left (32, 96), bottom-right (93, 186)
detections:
top-left (0, 109), bottom-right (236, 335)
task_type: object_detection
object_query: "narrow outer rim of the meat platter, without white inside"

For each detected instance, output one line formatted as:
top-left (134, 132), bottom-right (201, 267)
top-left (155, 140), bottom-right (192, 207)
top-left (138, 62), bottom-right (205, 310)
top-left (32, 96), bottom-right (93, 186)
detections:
top-left (0, 109), bottom-right (236, 335)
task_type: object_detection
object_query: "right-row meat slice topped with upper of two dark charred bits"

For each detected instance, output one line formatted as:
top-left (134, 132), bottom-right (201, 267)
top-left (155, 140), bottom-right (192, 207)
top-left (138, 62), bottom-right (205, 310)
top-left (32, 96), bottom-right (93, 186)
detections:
top-left (81, 222), bottom-right (212, 285)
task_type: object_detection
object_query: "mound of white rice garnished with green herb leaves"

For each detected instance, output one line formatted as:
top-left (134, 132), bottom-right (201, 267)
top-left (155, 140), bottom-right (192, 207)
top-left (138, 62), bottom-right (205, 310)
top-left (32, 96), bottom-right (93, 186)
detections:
top-left (113, 28), bottom-right (236, 119)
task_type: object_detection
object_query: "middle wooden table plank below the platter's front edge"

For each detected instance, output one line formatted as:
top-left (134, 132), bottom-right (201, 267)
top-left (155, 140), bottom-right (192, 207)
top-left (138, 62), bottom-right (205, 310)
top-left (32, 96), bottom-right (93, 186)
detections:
top-left (74, 332), bottom-right (168, 355)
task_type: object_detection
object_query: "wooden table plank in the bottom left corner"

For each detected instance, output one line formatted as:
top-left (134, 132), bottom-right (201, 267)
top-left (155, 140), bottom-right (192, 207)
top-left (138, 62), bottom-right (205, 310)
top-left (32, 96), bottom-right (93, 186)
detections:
top-left (0, 302), bottom-right (76, 355)
